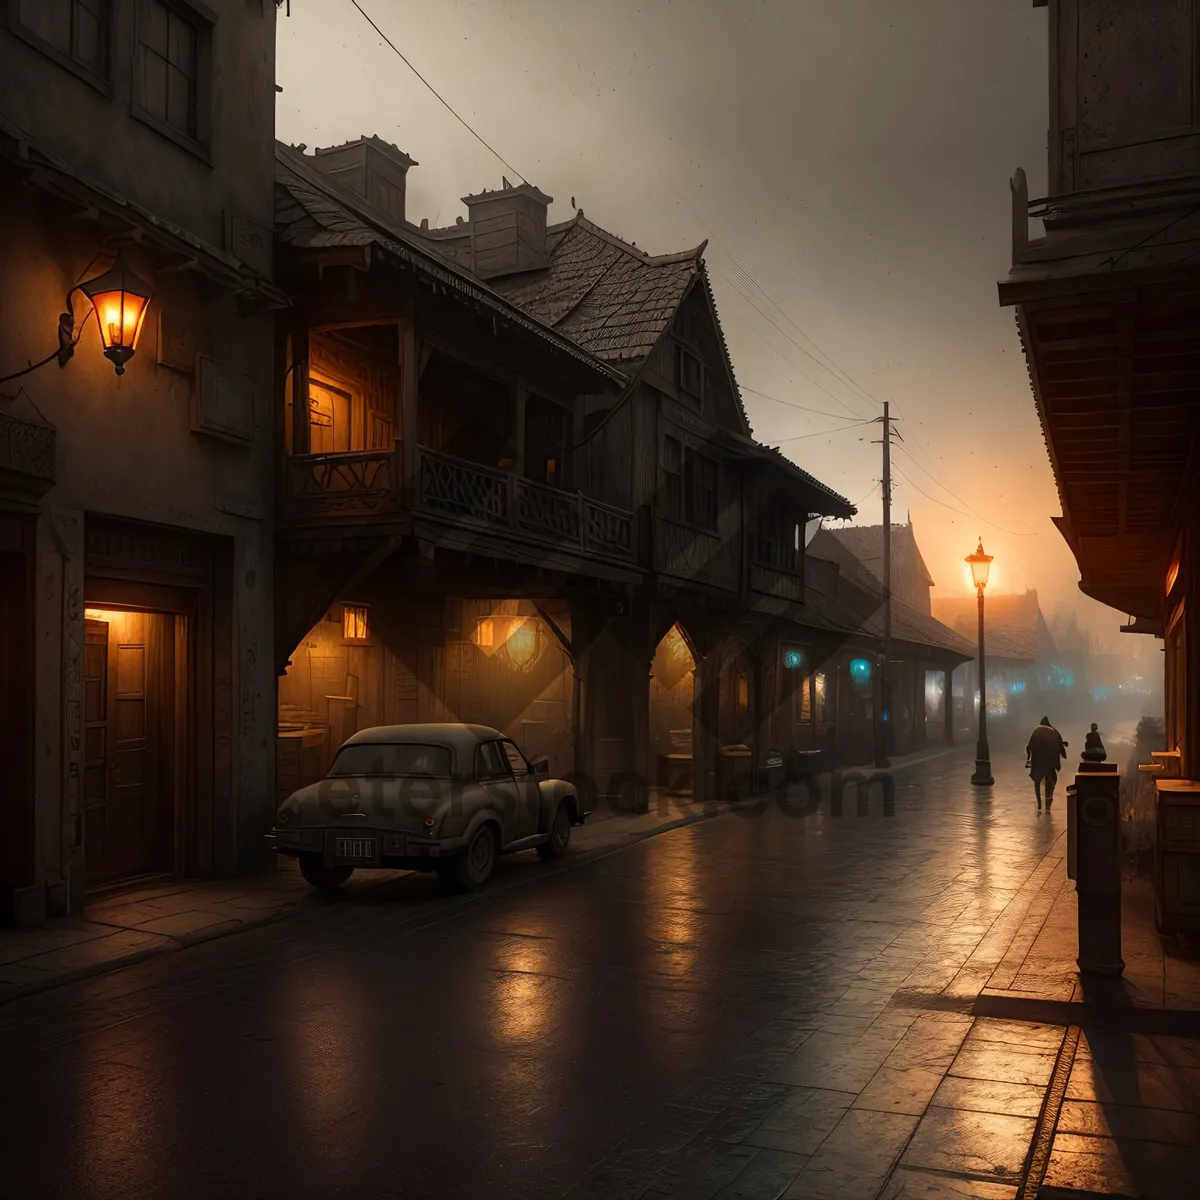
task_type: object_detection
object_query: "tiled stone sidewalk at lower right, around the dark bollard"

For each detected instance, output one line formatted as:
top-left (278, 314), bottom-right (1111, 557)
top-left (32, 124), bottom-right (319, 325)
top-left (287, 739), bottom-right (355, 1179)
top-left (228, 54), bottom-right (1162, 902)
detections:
top-left (883, 839), bottom-right (1200, 1200)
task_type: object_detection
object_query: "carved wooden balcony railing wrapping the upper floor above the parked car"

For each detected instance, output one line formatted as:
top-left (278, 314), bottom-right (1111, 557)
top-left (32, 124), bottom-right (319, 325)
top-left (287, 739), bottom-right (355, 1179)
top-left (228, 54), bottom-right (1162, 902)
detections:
top-left (280, 442), bottom-right (637, 566)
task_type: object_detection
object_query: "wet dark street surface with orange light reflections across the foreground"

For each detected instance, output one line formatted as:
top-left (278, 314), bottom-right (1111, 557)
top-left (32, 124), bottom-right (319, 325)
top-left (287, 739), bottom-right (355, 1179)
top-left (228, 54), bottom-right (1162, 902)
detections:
top-left (0, 754), bottom-right (1089, 1200)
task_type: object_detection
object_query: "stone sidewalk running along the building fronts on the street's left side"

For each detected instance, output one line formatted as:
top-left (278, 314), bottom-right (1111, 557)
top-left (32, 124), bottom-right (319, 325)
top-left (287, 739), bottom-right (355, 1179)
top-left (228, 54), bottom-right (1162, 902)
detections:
top-left (0, 748), bottom-right (958, 1003)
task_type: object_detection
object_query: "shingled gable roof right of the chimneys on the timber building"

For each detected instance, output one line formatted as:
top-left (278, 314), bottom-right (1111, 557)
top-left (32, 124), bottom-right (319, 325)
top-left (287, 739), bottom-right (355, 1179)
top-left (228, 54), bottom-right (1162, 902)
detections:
top-left (492, 212), bottom-right (707, 362)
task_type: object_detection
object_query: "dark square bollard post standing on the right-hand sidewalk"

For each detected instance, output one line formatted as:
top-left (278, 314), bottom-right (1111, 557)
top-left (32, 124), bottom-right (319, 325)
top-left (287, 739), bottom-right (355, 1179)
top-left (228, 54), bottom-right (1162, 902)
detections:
top-left (1068, 762), bottom-right (1124, 976)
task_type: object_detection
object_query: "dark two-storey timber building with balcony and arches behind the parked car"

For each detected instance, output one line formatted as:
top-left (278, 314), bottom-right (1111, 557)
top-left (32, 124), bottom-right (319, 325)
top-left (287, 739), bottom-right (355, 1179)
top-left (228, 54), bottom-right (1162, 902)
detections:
top-left (275, 138), bottom-right (853, 808)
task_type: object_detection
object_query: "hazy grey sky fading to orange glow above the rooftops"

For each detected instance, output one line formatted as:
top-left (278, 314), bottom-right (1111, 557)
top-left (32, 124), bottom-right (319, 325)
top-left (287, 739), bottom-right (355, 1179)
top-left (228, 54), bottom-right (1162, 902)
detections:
top-left (277, 0), bottom-right (1128, 642)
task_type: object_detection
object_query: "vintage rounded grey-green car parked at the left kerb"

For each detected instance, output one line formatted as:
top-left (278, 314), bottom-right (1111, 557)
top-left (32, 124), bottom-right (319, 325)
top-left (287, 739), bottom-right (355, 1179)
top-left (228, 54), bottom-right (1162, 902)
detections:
top-left (266, 724), bottom-right (587, 889)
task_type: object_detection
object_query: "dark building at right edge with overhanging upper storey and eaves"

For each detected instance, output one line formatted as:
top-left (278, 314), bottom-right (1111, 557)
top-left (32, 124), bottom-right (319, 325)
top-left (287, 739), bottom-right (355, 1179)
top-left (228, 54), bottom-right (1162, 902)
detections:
top-left (1000, 0), bottom-right (1200, 776)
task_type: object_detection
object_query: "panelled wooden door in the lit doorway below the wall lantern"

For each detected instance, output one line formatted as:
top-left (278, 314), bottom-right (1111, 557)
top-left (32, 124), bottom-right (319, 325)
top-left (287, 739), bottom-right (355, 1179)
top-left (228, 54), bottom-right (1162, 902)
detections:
top-left (84, 612), bottom-right (170, 884)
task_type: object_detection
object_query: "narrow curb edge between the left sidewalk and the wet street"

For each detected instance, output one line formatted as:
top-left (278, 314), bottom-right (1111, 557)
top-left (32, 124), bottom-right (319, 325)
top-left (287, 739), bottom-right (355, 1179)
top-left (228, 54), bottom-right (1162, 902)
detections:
top-left (0, 745), bottom-right (954, 1009)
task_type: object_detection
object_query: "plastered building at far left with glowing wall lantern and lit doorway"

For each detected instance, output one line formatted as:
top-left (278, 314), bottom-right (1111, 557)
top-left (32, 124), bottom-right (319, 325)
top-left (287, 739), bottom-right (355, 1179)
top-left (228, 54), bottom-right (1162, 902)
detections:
top-left (0, 0), bottom-right (287, 923)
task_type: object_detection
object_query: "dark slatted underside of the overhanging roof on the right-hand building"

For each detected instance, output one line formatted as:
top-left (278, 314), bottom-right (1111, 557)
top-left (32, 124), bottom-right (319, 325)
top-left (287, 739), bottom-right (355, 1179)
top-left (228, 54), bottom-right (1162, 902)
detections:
top-left (1018, 278), bottom-right (1200, 618)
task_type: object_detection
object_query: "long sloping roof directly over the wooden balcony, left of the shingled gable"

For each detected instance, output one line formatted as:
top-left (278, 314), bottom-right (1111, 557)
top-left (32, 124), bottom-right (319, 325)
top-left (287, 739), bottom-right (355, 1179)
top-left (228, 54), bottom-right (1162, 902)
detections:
top-left (275, 142), bottom-right (625, 384)
